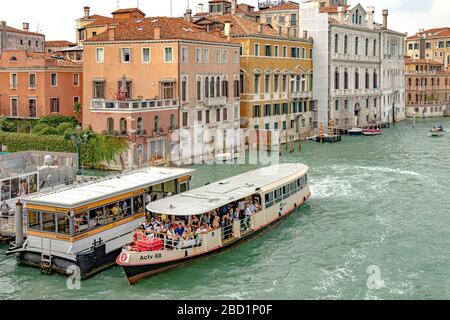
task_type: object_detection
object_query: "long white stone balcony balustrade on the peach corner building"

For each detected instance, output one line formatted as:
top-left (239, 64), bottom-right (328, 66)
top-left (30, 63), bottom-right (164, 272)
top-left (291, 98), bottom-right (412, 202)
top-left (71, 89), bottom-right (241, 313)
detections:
top-left (91, 99), bottom-right (179, 112)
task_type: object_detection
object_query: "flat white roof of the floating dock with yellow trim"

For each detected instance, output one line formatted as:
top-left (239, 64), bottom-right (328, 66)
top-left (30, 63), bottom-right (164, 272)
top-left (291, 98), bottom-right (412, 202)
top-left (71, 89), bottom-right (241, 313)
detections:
top-left (23, 167), bottom-right (194, 209)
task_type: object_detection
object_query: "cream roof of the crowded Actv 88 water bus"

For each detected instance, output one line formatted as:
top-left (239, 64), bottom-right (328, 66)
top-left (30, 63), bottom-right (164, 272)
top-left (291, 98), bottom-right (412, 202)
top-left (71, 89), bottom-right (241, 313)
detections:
top-left (147, 163), bottom-right (308, 216)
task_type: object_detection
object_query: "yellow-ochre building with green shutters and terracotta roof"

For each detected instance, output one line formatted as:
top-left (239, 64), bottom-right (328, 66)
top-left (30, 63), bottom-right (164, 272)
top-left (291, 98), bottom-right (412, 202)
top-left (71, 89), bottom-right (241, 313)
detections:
top-left (196, 1), bottom-right (314, 143)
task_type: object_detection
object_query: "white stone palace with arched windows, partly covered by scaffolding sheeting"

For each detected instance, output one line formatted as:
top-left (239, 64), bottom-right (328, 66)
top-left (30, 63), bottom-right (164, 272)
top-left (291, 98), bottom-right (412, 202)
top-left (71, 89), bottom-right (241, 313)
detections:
top-left (299, 0), bottom-right (406, 131)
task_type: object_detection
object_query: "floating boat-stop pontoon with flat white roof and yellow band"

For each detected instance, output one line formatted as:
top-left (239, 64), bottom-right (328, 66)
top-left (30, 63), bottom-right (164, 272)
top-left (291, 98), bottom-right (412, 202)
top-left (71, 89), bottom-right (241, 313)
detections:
top-left (7, 167), bottom-right (193, 279)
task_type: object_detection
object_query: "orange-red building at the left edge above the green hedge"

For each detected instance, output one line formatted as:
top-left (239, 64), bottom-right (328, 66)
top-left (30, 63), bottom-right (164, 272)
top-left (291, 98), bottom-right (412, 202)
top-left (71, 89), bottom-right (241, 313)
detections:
top-left (0, 50), bottom-right (83, 119)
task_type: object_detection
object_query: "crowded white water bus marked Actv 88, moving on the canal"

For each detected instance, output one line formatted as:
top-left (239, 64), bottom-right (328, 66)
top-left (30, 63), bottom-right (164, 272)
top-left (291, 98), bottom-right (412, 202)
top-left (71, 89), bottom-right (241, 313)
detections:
top-left (116, 163), bottom-right (311, 284)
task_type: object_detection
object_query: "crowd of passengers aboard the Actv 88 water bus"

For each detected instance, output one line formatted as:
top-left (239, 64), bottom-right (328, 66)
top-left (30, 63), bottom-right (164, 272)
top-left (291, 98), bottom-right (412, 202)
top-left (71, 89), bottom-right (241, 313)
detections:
top-left (140, 196), bottom-right (261, 239)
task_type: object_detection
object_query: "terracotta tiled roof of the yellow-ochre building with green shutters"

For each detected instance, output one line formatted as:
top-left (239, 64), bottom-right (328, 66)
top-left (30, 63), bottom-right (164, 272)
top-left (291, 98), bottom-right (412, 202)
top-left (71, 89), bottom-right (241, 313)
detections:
top-left (202, 14), bottom-right (286, 37)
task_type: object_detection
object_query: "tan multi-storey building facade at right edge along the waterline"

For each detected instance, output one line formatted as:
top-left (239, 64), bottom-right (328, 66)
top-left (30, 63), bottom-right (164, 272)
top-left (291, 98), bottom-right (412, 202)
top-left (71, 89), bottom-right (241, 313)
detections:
top-left (406, 59), bottom-right (450, 118)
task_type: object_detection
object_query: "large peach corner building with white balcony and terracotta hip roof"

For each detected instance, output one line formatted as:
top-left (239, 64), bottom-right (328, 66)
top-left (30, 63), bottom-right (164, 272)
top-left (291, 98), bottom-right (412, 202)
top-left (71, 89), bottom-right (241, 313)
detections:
top-left (83, 17), bottom-right (240, 162)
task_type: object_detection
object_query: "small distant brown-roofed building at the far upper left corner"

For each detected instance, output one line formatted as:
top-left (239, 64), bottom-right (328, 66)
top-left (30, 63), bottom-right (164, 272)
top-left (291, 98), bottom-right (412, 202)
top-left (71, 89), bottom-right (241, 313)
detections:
top-left (0, 21), bottom-right (45, 54)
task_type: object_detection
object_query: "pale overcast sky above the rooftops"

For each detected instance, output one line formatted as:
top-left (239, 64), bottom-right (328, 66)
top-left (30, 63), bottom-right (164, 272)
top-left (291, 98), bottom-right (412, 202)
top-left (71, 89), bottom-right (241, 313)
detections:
top-left (0, 0), bottom-right (450, 41)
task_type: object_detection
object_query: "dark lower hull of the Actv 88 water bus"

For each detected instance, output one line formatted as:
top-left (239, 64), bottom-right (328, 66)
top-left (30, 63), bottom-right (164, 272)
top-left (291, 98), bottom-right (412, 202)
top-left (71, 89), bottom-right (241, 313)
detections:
top-left (117, 193), bottom-right (311, 285)
